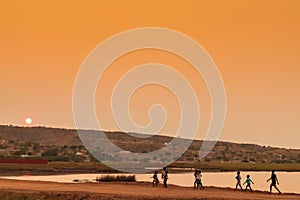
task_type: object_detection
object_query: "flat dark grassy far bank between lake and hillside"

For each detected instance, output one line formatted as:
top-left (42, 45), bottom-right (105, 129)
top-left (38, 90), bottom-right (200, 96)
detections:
top-left (0, 162), bottom-right (300, 176)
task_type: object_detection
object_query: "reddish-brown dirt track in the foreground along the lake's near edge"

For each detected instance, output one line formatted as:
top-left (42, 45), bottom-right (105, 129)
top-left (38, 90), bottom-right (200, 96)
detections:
top-left (0, 179), bottom-right (300, 200)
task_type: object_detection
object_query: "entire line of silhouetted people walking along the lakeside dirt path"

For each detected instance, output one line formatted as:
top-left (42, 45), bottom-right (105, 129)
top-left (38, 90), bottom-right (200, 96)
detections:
top-left (152, 167), bottom-right (281, 194)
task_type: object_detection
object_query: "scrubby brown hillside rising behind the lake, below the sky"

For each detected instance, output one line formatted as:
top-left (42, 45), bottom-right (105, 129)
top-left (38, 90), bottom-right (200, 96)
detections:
top-left (0, 126), bottom-right (300, 163)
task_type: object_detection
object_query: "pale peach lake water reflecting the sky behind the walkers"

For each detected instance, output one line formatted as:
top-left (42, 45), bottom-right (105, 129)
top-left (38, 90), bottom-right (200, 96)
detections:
top-left (1, 172), bottom-right (300, 193)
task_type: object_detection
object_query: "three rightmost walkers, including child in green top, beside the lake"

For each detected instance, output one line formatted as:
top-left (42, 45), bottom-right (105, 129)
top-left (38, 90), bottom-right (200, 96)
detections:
top-left (235, 170), bottom-right (281, 194)
